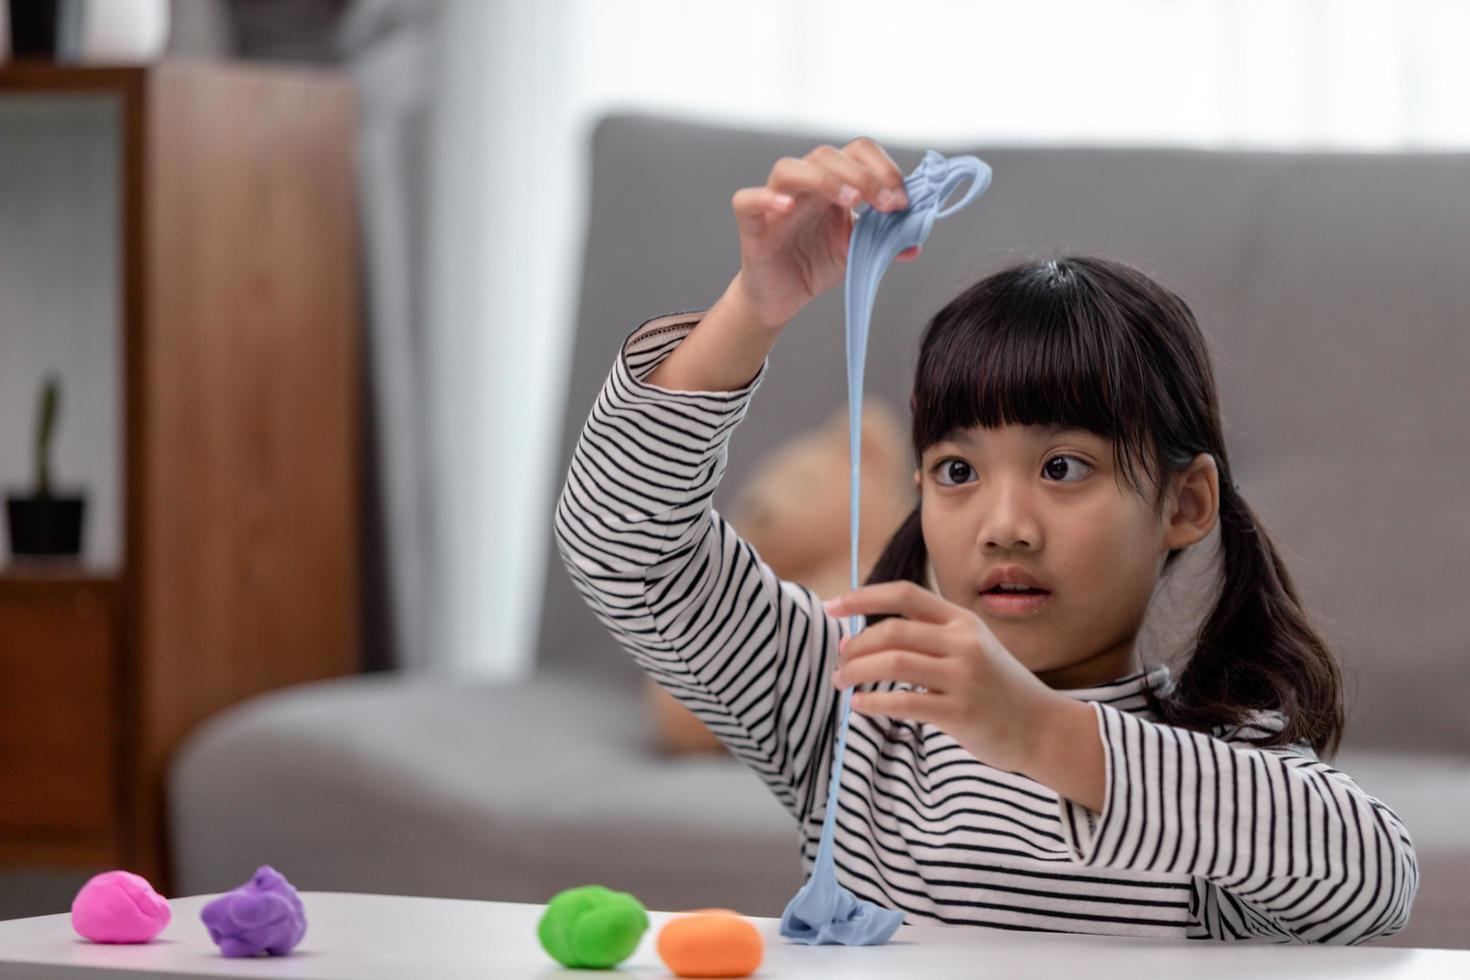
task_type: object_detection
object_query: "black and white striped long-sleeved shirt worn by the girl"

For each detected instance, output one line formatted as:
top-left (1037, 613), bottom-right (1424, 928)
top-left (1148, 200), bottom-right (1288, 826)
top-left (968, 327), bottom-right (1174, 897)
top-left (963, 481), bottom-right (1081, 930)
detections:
top-left (554, 311), bottom-right (1419, 945)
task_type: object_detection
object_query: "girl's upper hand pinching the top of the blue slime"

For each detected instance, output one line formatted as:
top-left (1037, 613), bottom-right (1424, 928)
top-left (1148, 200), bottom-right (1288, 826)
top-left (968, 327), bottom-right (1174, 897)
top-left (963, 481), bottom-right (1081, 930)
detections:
top-left (731, 137), bottom-right (922, 329)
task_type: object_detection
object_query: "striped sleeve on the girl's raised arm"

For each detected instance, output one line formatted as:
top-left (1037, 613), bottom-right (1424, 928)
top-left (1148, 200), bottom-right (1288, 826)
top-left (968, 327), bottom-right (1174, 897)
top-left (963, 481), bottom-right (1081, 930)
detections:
top-left (554, 311), bottom-right (844, 821)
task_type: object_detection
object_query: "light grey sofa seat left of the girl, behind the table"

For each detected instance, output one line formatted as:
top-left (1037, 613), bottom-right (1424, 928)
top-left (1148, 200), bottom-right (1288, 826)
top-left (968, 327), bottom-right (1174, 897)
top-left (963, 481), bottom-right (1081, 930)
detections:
top-left (169, 674), bottom-right (803, 915)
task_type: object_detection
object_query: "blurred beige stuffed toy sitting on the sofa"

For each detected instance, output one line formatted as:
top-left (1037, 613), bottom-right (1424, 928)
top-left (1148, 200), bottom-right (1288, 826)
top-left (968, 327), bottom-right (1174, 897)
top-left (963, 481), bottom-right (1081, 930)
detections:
top-left (645, 398), bottom-right (917, 752)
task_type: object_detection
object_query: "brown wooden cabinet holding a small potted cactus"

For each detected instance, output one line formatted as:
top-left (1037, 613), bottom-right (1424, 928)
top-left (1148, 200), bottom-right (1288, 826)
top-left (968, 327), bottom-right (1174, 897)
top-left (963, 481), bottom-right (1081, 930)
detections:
top-left (0, 62), bottom-right (360, 892)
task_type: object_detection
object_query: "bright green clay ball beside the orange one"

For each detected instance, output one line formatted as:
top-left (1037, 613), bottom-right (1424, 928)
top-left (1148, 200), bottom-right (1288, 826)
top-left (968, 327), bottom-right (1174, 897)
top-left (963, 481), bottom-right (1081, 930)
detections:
top-left (537, 884), bottom-right (648, 970)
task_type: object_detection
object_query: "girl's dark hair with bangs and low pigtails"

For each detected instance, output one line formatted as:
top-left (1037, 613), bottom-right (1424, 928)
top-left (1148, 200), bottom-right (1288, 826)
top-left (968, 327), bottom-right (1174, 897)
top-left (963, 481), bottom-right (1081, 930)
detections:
top-left (867, 256), bottom-right (1344, 755)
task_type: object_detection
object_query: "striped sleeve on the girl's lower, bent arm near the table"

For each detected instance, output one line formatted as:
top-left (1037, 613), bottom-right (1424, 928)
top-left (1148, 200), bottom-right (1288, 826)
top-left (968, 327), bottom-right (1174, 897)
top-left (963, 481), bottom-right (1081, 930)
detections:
top-left (1060, 702), bottom-right (1419, 945)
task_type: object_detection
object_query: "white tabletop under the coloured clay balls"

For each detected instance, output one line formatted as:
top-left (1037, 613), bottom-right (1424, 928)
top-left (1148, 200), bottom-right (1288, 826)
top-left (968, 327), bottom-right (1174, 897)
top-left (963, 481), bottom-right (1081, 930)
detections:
top-left (0, 892), bottom-right (1470, 980)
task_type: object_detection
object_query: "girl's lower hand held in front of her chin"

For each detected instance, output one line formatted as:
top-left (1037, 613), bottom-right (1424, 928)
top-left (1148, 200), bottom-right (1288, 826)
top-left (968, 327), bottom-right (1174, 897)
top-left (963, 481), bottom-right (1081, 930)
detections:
top-left (826, 582), bottom-right (1076, 774)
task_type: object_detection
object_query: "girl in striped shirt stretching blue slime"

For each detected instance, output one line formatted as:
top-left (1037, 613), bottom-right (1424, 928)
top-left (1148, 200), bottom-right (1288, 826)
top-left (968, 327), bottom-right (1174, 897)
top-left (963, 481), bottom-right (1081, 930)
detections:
top-left (556, 138), bottom-right (1419, 943)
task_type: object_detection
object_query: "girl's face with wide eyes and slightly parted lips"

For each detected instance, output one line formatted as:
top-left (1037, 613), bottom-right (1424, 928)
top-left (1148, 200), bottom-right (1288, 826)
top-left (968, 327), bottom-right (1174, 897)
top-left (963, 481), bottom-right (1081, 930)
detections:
top-left (914, 425), bottom-right (1219, 689)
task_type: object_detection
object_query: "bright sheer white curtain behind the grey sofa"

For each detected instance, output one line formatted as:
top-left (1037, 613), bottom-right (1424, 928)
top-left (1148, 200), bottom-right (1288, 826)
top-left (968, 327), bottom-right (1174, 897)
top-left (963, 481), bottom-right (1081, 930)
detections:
top-left (431, 0), bottom-right (1470, 677)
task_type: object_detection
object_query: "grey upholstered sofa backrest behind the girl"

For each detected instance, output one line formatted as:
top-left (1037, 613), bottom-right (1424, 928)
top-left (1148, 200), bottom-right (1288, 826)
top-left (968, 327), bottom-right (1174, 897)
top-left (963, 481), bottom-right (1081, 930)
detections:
top-left (538, 113), bottom-right (1470, 752)
